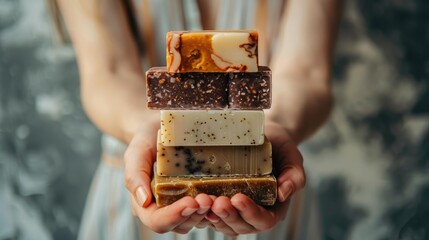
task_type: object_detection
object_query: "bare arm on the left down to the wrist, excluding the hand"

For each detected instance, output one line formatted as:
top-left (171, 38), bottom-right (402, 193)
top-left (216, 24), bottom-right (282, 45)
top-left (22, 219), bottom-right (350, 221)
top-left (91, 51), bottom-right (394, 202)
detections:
top-left (58, 0), bottom-right (148, 141)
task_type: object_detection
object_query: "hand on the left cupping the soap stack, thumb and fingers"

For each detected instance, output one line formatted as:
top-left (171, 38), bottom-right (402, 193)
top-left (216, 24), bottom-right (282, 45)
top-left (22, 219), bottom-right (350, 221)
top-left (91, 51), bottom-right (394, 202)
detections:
top-left (124, 116), bottom-right (213, 234)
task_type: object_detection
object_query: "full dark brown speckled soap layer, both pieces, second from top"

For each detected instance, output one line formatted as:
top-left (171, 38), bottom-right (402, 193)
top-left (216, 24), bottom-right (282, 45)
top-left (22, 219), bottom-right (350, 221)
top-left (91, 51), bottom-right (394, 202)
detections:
top-left (146, 66), bottom-right (271, 109)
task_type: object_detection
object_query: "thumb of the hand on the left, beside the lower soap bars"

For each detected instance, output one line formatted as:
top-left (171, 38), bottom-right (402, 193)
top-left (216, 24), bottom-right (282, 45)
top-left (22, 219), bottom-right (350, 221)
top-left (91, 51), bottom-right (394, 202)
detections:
top-left (124, 134), bottom-right (156, 207)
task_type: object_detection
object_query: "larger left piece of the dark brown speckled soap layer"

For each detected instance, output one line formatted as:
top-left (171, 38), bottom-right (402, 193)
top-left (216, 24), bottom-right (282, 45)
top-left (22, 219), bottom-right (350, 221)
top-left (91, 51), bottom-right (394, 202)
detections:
top-left (146, 67), bottom-right (228, 109)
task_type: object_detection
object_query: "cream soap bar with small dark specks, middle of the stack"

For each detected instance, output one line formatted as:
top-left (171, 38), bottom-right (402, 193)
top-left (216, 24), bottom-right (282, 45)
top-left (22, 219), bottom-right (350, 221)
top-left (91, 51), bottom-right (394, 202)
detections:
top-left (161, 110), bottom-right (264, 146)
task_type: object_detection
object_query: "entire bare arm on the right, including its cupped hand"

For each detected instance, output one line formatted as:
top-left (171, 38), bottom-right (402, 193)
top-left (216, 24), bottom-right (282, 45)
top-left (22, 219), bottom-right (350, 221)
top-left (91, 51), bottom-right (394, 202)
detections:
top-left (207, 0), bottom-right (341, 236)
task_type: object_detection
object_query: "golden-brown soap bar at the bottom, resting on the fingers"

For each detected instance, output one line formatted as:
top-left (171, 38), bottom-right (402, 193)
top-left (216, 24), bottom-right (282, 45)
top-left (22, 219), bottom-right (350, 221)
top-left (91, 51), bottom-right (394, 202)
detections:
top-left (152, 175), bottom-right (277, 207)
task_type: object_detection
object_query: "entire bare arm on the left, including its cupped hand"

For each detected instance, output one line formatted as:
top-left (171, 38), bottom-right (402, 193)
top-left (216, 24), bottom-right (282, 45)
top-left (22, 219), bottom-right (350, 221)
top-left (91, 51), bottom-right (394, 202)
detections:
top-left (58, 0), bottom-right (213, 233)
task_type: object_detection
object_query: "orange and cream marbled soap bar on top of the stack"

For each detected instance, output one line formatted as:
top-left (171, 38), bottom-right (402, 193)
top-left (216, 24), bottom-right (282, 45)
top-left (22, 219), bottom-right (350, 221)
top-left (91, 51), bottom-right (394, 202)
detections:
top-left (167, 30), bottom-right (258, 72)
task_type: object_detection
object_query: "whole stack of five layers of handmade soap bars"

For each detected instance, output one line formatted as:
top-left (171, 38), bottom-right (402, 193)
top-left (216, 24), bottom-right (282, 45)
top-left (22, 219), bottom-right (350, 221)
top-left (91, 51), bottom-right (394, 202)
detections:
top-left (146, 31), bottom-right (277, 206)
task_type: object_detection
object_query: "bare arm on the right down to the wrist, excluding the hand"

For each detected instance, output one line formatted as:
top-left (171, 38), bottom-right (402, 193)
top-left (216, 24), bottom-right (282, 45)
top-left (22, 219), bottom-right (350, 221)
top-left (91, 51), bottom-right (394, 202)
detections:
top-left (267, 0), bottom-right (341, 143)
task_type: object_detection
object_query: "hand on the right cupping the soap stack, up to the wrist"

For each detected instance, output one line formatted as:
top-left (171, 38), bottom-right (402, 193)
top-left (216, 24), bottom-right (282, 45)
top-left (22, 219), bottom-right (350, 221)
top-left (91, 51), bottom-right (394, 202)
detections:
top-left (201, 122), bottom-right (305, 236)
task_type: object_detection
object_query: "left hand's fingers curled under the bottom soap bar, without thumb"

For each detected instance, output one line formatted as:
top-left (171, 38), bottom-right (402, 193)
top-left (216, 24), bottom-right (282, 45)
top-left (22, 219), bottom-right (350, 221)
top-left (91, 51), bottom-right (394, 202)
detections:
top-left (132, 197), bottom-right (199, 233)
